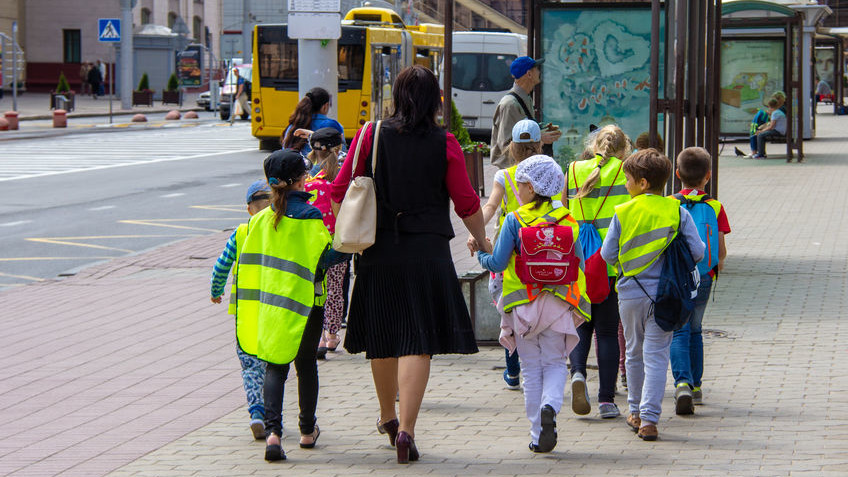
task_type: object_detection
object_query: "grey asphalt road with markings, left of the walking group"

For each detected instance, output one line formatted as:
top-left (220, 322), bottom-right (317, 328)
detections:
top-left (0, 123), bottom-right (267, 288)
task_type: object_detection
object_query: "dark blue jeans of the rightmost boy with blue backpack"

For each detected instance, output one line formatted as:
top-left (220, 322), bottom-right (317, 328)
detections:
top-left (671, 274), bottom-right (713, 388)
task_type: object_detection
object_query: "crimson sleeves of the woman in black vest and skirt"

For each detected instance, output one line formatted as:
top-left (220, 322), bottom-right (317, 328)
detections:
top-left (330, 123), bottom-right (480, 219)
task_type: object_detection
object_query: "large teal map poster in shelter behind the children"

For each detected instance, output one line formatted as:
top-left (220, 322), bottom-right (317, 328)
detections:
top-left (541, 7), bottom-right (665, 167)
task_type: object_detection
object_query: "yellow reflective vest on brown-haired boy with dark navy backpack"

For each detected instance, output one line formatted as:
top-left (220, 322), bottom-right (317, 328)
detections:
top-left (615, 194), bottom-right (680, 277)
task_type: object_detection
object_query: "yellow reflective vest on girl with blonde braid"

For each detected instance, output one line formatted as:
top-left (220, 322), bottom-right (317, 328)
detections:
top-left (566, 155), bottom-right (630, 277)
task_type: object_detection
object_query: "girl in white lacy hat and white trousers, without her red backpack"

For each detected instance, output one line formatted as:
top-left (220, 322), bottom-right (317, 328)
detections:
top-left (477, 155), bottom-right (591, 452)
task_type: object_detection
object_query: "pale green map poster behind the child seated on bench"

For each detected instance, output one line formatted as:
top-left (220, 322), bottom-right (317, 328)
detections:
top-left (719, 38), bottom-right (785, 136)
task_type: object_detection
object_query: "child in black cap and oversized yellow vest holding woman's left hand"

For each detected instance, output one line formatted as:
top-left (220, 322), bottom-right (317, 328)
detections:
top-left (236, 149), bottom-right (349, 461)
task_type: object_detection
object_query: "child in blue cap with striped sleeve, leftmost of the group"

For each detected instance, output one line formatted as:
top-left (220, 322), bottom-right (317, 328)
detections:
top-left (212, 180), bottom-right (271, 439)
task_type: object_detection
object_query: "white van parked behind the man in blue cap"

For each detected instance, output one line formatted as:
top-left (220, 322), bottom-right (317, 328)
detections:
top-left (451, 31), bottom-right (527, 136)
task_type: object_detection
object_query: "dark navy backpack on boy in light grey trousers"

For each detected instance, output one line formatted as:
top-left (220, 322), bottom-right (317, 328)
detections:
top-left (633, 209), bottom-right (701, 331)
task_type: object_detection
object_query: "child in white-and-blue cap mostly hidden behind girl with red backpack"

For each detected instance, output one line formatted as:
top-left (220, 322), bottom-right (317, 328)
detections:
top-left (467, 119), bottom-right (542, 390)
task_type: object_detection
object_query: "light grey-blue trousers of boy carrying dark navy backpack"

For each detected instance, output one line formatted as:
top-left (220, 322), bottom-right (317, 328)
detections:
top-left (618, 297), bottom-right (672, 425)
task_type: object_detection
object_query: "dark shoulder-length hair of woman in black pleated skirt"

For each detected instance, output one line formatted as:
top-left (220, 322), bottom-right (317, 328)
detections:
top-left (388, 65), bottom-right (442, 133)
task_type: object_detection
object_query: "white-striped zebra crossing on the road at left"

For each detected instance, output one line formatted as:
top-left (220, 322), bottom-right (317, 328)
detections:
top-left (0, 124), bottom-right (257, 182)
